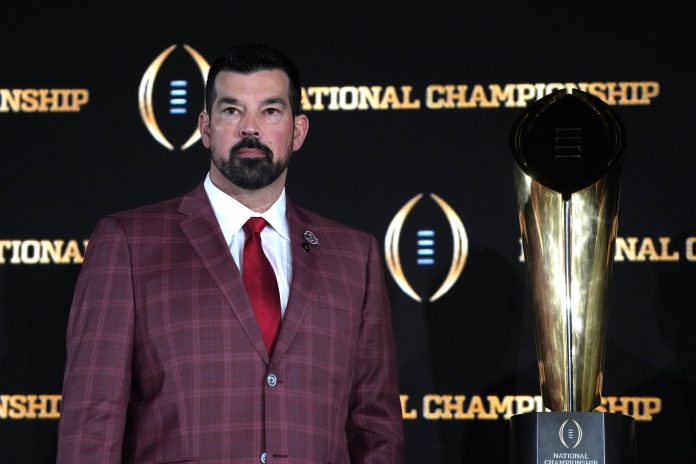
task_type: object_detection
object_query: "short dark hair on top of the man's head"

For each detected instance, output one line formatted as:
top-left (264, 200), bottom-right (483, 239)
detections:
top-left (205, 44), bottom-right (302, 116)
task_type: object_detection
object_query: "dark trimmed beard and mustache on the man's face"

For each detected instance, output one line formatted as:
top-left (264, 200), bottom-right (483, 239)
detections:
top-left (211, 137), bottom-right (293, 190)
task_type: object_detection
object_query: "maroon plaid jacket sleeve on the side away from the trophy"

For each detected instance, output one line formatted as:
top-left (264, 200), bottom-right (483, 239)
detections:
top-left (57, 218), bottom-right (134, 464)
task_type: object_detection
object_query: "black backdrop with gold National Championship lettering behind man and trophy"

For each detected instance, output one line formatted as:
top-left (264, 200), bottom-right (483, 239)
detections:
top-left (0, 2), bottom-right (696, 463)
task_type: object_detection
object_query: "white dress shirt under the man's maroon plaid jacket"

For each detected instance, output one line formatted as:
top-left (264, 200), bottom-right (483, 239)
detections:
top-left (203, 173), bottom-right (292, 317)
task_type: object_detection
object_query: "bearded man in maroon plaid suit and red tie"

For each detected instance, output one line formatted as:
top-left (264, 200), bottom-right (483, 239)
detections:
top-left (58, 45), bottom-right (403, 464)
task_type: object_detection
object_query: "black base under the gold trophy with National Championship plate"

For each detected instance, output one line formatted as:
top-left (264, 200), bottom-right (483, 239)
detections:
top-left (510, 411), bottom-right (636, 464)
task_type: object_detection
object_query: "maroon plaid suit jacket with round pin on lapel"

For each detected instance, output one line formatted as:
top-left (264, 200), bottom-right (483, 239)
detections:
top-left (58, 186), bottom-right (403, 464)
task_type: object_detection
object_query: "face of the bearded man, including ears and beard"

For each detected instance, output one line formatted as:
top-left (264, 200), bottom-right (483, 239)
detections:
top-left (198, 70), bottom-right (308, 190)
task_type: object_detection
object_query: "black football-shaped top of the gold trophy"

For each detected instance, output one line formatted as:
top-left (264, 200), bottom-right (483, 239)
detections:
top-left (511, 89), bottom-right (625, 198)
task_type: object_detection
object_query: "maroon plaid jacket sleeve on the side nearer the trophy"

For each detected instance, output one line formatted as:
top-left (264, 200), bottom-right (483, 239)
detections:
top-left (346, 237), bottom-right (403, 464)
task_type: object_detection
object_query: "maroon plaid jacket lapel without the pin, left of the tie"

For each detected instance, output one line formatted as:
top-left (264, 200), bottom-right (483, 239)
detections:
top-left (179, 185), bottom-right (269, 364)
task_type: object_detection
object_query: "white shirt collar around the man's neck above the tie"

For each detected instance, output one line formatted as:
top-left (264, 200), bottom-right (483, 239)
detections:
top-left (203, 173), bottom-right (290, 243)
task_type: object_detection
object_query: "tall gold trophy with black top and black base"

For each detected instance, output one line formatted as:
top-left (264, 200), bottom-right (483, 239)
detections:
top-left (511, 89), bottom-right (635, 464)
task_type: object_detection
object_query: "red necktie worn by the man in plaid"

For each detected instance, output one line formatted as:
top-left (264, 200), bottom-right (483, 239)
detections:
top-left (242, 217), bottom-right (280, 353)
